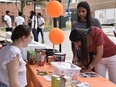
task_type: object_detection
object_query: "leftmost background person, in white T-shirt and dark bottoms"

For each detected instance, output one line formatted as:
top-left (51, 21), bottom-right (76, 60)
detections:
top-left (4, 10), bottom-right (13, 32)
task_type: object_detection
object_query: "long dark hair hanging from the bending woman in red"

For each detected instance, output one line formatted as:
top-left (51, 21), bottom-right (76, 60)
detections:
top-left (69, 29), bottom-right (90, 67)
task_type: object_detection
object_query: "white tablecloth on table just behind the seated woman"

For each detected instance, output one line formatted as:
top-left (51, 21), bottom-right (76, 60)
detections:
top-left (22, 41), bottom-right (47, 60)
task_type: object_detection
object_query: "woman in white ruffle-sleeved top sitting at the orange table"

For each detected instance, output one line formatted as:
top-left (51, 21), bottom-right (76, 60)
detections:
top-left (0, 25), bottom-right (32, 87)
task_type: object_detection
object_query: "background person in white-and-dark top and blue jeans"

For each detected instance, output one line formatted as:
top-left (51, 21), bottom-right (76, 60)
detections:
top-left (31, 11), bottom-right (38, 42)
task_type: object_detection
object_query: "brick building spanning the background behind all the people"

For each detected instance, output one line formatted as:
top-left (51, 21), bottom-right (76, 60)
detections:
top-left (0, 0), bottom-right (116, 27)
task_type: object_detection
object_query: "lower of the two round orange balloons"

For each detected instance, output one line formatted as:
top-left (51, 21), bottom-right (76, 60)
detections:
top-left (49, 28), bottom-right (64, 44)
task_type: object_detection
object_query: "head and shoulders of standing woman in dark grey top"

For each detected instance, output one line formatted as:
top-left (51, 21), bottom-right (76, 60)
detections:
top-left (72, 1), bottom-right (101, 29)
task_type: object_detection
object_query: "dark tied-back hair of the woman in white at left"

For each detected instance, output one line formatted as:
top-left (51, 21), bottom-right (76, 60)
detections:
top-left (11, 25), bottom-right (31, 41)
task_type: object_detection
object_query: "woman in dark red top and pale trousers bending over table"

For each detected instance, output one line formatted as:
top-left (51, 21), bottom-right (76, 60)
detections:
top-left (69, 26), bottom-right (116, 84)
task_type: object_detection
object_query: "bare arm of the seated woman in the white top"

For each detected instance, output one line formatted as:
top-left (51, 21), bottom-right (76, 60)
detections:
top-left (6, 56), bottom-right (22, 87)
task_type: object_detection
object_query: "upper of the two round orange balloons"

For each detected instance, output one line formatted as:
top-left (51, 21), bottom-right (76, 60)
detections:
top-left (46, 1), bottom-right (63, 18)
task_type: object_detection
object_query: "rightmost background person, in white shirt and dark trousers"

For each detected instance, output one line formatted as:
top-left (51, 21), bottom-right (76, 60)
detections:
top-left (37, 13), bottom-right (45, 43)
